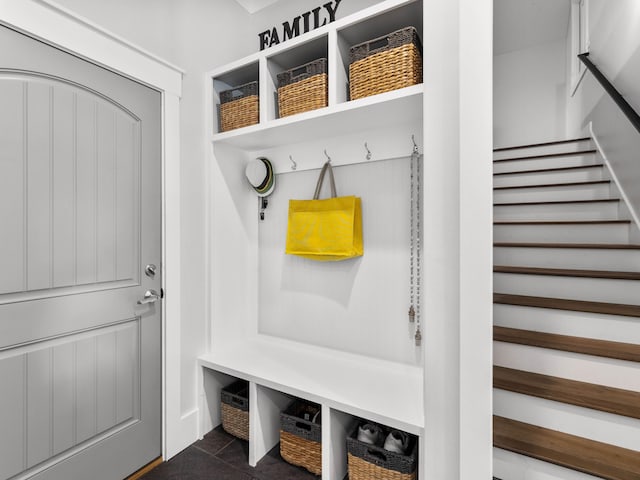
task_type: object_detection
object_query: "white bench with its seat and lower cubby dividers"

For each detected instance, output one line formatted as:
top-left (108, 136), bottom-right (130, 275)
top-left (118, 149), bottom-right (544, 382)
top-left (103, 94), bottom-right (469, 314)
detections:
top-left (199, 336), bottom-right (424, 480)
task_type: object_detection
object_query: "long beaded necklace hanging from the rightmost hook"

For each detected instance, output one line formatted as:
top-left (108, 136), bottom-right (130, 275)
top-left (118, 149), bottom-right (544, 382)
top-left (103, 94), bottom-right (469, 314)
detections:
top-left (409, 141), bottom-right (422, 347)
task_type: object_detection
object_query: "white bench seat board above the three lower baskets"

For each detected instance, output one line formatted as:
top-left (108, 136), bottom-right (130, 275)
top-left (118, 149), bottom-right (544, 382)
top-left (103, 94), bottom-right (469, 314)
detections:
top-left (198, 335), bottom-right (424, 435)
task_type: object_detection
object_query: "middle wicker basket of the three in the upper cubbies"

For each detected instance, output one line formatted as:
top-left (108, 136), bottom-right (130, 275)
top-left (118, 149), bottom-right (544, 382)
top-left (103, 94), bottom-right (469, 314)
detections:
top-left (278, 58), bottom-right (327, 118)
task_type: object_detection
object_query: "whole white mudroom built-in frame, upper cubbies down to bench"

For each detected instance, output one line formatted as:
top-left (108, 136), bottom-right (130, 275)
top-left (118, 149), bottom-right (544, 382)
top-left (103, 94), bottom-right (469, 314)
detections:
top-left (199, 0), bottom-right (425, 480)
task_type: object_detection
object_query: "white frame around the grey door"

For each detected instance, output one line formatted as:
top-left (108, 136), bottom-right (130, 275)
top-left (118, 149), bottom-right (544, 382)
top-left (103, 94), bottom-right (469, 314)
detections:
top-left (0, 0), bottom-right (188, 460)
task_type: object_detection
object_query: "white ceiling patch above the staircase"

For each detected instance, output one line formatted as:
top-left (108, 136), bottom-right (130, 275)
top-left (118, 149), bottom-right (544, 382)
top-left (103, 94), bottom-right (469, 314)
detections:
top-left (493, 0), bottom-right (571, 55)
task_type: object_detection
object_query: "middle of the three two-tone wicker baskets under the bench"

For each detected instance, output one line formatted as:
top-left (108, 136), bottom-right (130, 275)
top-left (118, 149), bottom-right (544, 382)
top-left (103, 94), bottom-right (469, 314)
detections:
top-left (280, 400), bottom-right (322, 475)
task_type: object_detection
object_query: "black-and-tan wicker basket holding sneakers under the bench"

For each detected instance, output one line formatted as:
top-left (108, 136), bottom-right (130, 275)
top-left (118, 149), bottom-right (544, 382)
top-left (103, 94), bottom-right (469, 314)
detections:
top-left (347, 423), bottom-right (418, 480)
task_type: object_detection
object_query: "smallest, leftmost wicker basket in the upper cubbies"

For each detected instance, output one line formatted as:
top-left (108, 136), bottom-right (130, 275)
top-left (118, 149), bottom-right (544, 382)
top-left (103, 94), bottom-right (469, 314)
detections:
top-left (220, 82), bottom-right (260, 132)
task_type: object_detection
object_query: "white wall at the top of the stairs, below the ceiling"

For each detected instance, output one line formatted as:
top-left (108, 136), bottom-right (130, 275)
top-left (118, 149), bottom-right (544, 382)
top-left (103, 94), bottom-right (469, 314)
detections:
top-left (493, 39), bottom-right (567, 147)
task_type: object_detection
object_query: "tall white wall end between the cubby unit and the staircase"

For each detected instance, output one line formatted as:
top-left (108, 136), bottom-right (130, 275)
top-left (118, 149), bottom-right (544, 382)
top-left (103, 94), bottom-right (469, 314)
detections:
top-left (428, 0), bottom-right (493, 480)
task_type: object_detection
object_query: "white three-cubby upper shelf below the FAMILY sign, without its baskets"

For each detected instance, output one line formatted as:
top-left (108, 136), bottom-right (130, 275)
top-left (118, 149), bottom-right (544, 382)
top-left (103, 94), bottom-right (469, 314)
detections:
top-left (208, 0), bottom-right (424, 151)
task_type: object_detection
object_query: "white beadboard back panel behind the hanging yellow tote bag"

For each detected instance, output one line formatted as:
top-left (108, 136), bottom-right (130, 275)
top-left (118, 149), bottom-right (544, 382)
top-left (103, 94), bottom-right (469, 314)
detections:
top-left (259, 158), bottom-right (422, 364)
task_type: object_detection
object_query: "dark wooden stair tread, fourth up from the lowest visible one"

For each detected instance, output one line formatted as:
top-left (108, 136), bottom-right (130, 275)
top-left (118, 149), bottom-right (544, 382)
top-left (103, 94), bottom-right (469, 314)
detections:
top-left (493, 293), bottom-right (640, 317)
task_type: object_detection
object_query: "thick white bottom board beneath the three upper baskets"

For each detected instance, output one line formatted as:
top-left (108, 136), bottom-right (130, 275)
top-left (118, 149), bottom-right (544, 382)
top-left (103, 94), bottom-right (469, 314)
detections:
top-left (212, 84), bottom-right (423, 150)
